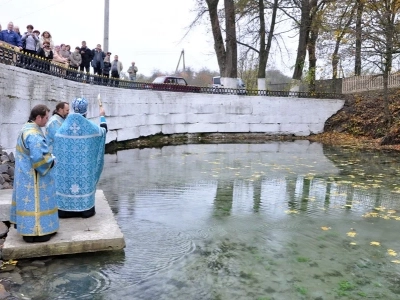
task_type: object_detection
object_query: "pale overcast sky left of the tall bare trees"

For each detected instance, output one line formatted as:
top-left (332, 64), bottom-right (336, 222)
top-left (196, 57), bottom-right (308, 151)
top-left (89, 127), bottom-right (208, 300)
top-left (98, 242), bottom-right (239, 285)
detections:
top-left (0, 0), bottom-right (218, 76)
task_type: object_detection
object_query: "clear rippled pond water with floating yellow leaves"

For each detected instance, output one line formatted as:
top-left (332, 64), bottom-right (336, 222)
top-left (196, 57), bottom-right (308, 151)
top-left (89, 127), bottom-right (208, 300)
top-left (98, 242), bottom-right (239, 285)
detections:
top-left (2, 141), bottom-right (400, 300)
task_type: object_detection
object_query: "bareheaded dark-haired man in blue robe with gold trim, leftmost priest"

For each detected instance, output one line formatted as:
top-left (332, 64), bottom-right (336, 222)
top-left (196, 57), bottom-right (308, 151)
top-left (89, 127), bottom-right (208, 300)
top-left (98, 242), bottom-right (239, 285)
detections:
top-left (10, 104), bottom-right (59, 242)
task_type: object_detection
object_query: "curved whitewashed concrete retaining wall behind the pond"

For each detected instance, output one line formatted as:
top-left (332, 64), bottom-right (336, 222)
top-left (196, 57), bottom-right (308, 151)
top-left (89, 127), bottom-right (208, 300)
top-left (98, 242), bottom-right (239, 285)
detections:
top-left (0, 64), bottom-right (344, 149)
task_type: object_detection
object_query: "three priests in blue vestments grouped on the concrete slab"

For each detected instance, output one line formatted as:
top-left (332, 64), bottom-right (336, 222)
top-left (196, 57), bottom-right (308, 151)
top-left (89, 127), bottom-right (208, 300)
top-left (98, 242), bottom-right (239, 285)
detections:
top-left (10, 98), bottom-right (108, 243)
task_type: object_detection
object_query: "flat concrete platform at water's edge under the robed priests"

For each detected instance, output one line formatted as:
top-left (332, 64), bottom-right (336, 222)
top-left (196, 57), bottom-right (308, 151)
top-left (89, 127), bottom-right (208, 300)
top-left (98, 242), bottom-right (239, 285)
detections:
top-left (0, 190), bottom-right (125, 260)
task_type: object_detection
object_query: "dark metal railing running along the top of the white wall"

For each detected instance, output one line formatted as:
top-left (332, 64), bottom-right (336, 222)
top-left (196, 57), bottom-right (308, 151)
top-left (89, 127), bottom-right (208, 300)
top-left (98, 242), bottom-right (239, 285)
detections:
top-left (0, 42), bottom-right (343, 99)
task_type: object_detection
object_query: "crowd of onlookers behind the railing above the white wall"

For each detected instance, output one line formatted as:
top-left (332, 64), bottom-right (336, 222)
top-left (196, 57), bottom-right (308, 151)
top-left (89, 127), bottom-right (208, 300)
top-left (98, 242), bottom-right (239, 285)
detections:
top-left (0, 22), bottom-right (138, 81)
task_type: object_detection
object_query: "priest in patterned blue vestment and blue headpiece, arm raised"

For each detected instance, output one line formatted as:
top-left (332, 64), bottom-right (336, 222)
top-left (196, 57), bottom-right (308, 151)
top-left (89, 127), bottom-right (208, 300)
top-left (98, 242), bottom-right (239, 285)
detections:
top-left (53, 98), bottom-right (107, 218)
